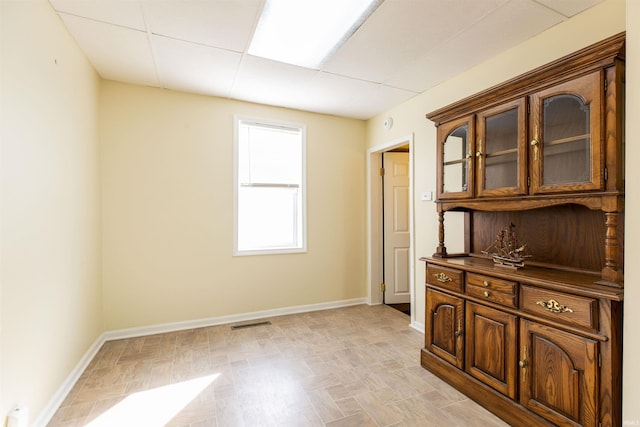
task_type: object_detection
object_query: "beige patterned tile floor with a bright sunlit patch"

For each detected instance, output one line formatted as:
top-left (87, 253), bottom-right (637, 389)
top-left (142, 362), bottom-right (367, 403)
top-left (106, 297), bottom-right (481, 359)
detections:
top-left (49, 305), bottom-right (506, 427)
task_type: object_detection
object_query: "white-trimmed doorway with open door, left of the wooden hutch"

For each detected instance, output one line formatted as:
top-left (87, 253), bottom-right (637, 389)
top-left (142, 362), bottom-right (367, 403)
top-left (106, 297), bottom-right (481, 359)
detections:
top-left (367, 135), bottom-right (415, 324)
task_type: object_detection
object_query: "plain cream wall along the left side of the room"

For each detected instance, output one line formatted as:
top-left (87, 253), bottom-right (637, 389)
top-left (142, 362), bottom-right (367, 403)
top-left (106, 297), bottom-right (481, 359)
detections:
top-left (0, 0), bottom-right (102, 425)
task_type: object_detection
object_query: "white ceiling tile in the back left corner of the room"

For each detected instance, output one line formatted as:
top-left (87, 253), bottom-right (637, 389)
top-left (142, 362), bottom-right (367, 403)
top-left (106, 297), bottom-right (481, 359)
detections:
top-left (60, 13), bottom-right (159, 86)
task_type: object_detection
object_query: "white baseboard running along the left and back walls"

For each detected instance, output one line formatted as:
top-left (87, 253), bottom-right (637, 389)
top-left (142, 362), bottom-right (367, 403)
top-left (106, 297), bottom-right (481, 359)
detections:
top-left (32, 298), bottom-right (367, 427)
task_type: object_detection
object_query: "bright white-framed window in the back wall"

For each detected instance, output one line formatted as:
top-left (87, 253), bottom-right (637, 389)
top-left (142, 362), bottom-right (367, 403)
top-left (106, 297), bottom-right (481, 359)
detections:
top-left (234, 117), bottom-right (306, 255)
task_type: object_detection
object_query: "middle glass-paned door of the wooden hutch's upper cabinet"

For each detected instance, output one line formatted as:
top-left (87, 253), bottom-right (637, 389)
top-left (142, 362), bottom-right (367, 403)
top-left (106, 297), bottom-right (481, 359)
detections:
top-left (475, 98), bottom-right (527, 197)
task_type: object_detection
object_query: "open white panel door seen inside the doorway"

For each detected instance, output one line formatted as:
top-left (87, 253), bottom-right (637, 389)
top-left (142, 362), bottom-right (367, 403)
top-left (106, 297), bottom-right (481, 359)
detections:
top-left (382, 153), bottom-right (411, 304)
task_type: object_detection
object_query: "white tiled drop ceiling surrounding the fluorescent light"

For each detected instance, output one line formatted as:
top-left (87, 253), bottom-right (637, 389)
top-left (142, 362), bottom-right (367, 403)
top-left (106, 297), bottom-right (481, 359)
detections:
top-left (50, 0), bottom-right (602, 119)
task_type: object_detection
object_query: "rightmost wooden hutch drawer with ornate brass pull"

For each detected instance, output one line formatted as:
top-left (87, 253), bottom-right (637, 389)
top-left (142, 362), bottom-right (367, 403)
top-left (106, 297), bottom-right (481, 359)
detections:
top-left (520, 285), bottom-right (598, 330)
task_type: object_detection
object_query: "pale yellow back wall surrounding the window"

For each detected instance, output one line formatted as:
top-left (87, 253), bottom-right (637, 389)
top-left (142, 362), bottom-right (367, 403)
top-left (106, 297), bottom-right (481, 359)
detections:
top-left (100, 82), bottom-right (366, 330)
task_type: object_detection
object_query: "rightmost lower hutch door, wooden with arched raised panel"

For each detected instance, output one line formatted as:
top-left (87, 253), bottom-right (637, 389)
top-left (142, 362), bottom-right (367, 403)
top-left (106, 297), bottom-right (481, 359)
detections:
top-left (519, 320), bottom-right (599, 426)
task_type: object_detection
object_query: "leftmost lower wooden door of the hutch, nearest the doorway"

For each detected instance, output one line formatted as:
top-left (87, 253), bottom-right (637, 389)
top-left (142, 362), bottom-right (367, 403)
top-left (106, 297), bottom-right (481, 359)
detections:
top-left (425, 289), bottom-right (464, 369)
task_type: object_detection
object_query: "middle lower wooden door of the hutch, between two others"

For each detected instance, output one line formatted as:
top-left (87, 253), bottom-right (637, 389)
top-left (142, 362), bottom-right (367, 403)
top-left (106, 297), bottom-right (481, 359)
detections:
top-left (465, 302), bottom-right (518, 399)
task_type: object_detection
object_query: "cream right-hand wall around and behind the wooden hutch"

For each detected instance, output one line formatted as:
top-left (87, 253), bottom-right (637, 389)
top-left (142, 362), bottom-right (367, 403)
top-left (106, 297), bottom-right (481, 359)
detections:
top-left (367, 0), bottom-right (640, 418)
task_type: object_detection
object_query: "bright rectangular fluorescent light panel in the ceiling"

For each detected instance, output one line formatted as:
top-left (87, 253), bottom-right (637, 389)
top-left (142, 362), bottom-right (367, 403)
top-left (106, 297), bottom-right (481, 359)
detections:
top-left (248, 0), bottom-right (383, 69)
